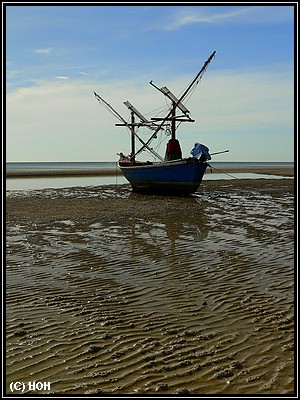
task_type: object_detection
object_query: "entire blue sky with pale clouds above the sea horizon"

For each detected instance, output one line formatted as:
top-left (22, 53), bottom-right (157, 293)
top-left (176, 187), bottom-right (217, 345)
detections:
top-left (5, 3), bottom-right (297, 161)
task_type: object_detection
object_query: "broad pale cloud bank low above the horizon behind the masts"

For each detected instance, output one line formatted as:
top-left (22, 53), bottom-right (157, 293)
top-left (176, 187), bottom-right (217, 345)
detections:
top-left (6, 69), bottom-right (294, 161)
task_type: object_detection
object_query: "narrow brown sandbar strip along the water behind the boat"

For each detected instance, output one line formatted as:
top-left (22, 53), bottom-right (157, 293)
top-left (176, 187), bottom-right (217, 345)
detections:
top-left (6, 166), bottom-right (294, 178)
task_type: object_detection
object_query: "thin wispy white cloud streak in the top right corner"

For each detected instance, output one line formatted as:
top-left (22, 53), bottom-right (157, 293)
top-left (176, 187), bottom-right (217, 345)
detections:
top-left (164, 6), bottom-right (293, 30)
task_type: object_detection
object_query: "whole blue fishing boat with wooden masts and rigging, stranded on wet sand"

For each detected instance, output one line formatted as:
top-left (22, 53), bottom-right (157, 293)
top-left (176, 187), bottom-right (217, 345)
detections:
top-left (94, 51), bottom-right (224, 195)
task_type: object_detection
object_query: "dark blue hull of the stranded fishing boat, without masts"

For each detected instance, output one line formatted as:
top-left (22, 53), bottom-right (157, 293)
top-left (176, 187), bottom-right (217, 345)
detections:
top-left (119, 158), bottom-right (208, 194)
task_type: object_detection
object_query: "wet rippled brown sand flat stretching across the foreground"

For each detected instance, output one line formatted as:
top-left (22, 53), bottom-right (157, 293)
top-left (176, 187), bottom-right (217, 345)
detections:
top-left (6, 179), bottom-right (294, 396)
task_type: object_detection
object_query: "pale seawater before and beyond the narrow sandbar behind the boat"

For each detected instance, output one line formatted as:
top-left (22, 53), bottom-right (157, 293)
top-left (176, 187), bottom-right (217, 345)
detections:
top-left (5, 162), bottom-right (294, 190)
